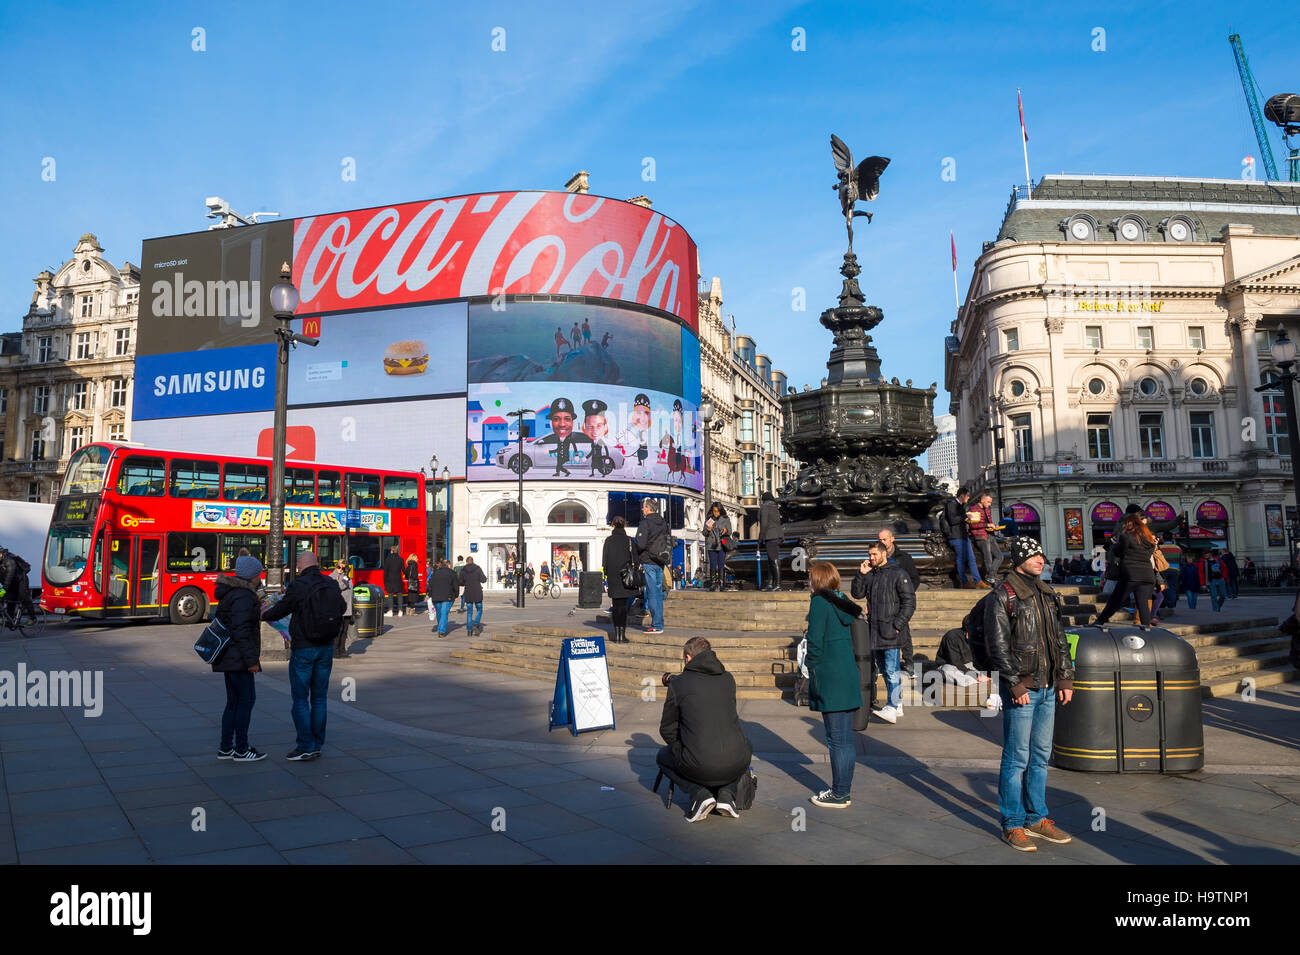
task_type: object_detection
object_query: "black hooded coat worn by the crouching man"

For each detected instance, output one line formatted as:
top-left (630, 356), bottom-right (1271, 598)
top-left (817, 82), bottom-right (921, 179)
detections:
top-left (659, 650), bottom-right (754, 786)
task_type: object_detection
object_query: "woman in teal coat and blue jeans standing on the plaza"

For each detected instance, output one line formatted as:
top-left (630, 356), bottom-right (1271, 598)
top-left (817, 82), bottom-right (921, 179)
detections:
top-left (805, 561), bottom-right (862, 809)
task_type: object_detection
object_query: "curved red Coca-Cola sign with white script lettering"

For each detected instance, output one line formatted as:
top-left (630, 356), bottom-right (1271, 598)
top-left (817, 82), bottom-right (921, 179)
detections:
top-left (294, 192), bottom-right (698, 331)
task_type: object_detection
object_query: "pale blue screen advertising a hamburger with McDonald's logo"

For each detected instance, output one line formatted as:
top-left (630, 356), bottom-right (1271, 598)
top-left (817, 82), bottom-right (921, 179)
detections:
top-left (289, 301), bottom-right (467, 407)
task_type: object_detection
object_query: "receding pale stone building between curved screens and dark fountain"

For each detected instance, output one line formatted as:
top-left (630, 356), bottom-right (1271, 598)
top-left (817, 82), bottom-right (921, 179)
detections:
top-left (699, 275), bottom-right (798, 538)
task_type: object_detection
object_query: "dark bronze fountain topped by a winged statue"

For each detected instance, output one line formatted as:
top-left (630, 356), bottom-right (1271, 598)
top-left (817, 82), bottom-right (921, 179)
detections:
top-left (759, 135), bottom-right (953, 586)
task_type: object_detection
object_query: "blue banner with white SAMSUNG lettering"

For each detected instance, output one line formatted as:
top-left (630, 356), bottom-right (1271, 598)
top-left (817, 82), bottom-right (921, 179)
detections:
top-left (131, 344), bottom-right (276, 421)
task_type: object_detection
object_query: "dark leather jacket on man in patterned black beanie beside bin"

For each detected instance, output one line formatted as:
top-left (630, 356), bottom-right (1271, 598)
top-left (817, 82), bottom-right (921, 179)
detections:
top-left (982, 570), bottom-right (1074, 698)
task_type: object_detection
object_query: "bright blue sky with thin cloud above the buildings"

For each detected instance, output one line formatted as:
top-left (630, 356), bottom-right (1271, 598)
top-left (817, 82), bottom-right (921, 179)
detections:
top-left (0, 0), bottom-right (1300, 411)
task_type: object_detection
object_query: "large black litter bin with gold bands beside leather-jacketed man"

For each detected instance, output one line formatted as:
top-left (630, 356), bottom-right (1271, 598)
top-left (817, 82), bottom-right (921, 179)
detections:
top-left (1052, 626), bottom-right (1205, 773)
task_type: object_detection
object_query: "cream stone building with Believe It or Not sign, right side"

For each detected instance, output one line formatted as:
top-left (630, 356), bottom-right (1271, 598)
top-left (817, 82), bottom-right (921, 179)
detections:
top-left (945, 175), bottom-right (1300, 564)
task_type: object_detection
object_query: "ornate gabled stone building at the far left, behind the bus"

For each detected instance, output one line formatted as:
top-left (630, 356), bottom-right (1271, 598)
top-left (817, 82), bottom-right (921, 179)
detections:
top-left (0, 233), bottom-right (140, 502)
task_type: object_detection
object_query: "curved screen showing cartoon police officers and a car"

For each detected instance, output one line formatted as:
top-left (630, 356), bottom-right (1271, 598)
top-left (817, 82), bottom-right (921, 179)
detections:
top-left (465, 382), bottom-right (703, 491)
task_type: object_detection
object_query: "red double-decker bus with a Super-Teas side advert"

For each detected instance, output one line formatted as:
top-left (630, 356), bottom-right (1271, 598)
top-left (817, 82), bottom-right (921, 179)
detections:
top-left (40, 443), bottom-right (428, 624)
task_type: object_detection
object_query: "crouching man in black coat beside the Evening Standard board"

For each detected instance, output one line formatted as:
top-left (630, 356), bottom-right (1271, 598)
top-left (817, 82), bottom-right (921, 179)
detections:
top-left (659, 637), bottom-right (754, 822)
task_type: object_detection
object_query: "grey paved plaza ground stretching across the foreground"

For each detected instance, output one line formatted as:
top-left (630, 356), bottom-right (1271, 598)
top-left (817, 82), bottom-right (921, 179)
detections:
top-left (0, 596), bottom-right (1300, 865)
